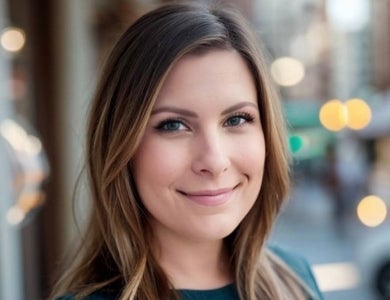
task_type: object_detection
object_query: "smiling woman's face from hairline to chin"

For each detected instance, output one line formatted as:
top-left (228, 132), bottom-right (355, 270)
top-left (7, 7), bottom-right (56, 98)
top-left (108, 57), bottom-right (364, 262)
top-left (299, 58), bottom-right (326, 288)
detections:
top-left (133, 50), bottom-right (265, 241)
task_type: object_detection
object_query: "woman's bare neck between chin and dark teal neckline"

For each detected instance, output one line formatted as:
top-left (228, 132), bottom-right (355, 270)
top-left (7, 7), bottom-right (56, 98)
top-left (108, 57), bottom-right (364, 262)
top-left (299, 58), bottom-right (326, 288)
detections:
top-left (155, 234), bottom-right (234, 289)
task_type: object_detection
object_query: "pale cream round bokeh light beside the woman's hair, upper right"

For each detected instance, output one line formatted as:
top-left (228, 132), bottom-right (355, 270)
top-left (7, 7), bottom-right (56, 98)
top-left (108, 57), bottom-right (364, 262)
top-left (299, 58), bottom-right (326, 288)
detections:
top-left (271, 57), bottom-right (305, 86)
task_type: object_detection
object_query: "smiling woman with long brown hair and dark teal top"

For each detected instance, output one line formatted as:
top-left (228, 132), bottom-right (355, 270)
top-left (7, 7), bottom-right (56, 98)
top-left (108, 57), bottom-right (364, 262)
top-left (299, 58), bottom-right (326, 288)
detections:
top-left (53, 4), bottom-right (321, 300)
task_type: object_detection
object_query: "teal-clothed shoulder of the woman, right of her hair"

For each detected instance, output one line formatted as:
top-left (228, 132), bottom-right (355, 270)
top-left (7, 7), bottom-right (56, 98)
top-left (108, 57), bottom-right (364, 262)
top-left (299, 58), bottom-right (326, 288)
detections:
top-left (268, 245), bottom-right (323, 299)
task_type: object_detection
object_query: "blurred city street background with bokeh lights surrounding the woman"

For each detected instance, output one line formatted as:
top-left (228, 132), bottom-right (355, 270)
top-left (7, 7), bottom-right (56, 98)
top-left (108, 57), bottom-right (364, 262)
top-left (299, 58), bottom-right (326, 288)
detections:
top-left (0, 0), bottom-right (390, 300)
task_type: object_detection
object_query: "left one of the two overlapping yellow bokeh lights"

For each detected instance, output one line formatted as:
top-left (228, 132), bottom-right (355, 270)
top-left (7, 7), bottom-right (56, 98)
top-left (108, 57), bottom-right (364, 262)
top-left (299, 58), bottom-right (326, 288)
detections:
top-left (319, 99), bottom-right (348, 131)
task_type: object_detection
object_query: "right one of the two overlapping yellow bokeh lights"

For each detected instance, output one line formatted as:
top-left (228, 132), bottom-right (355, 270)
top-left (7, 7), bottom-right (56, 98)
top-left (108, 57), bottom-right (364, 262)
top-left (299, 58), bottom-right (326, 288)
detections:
top-left (345, 98), bottom-right (371, 130)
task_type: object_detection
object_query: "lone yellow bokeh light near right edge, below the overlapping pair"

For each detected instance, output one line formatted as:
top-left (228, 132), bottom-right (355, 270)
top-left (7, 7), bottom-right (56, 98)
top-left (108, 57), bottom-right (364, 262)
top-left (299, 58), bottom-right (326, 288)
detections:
top-left (357, 195), bottom-right (387, 227)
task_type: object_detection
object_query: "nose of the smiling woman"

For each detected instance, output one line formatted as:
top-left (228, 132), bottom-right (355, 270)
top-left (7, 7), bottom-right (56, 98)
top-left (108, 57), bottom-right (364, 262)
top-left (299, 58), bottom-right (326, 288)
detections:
top-left (192, 134), bottom-right (231, 177)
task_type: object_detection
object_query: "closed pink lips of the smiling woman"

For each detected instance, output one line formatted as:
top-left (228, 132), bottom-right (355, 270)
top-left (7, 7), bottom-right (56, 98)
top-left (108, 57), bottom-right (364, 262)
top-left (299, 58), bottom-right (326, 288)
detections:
top-left (179, 188), bottom-right (234, 206)
